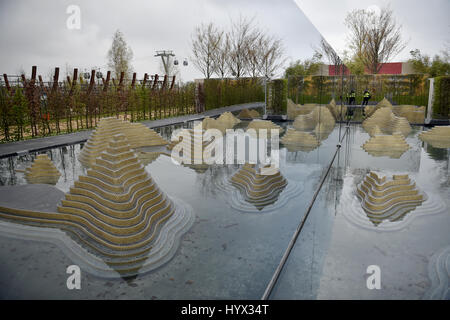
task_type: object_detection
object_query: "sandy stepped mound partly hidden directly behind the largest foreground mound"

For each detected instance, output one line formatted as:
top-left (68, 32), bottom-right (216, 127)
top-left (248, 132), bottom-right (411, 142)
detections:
top-left (78, 118), bottom-right (168, 167)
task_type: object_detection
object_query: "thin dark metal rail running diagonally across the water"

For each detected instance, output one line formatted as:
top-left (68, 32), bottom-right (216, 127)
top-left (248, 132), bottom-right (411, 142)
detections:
top-left (261, 123), bottom-right (350, 300)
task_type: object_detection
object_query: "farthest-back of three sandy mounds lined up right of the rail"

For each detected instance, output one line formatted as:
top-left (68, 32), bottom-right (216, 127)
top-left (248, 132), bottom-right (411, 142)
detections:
top-left (362, 108), bottom-right (411, 137)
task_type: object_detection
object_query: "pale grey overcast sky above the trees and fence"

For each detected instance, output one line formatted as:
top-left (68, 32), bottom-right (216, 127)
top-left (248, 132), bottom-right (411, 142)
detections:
top-left (0, 0), bottom-right (450, 81)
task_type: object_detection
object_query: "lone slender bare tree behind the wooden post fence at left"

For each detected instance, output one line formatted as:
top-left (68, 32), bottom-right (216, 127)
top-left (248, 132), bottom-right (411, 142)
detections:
top-left (108, 30), bottom-right (133, 79)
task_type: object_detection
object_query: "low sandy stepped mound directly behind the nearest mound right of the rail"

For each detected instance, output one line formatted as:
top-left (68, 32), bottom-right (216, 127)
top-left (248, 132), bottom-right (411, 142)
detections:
top-left (362, 130), bottom-right (410, 159)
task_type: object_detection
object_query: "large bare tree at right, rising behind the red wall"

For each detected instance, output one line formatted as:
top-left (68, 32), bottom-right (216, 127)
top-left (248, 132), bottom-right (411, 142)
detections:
top-left (345, 7), bottom-right (406, 74)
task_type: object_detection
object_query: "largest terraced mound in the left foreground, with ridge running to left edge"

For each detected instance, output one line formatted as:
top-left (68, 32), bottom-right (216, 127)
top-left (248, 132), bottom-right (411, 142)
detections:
top-left (0, 135), bottom-right (193, 277)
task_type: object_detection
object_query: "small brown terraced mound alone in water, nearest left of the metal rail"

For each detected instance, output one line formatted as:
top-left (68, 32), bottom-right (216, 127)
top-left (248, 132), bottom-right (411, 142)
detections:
top-left (230, 163), bottom-right (287, 211)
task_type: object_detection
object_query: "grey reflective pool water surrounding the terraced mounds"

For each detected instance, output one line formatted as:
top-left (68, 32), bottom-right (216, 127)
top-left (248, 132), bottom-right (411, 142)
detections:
top-left (0, 123), bottom-right (450, 299)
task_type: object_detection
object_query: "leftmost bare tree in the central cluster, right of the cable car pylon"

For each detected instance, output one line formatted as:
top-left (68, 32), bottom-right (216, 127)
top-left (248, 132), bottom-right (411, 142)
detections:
top-left (191, 23), bottom-right (223, 79)
